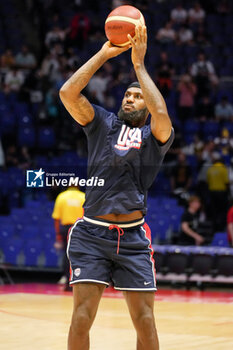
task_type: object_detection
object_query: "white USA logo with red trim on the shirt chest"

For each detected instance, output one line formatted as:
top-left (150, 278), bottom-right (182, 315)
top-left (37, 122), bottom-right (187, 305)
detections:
top-left (115, 125), bottom-right (142, 150)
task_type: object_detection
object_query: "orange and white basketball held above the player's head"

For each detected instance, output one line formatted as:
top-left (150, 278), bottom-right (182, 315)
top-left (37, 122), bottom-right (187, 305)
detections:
top-left (105, 5), bottom-right (145, 46)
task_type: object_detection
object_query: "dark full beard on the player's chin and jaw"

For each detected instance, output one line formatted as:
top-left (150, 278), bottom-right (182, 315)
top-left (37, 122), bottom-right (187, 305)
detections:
top-left (117, 106), bottom-right (148, 127)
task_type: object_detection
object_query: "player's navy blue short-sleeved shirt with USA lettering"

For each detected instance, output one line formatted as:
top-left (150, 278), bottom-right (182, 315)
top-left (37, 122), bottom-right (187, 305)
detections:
top-left (83, 105), bottom-right (174, 216)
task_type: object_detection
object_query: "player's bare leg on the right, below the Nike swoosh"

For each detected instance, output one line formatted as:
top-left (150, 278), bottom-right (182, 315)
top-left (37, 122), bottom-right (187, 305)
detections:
top-left (124, 291), bottom-right (159, 350)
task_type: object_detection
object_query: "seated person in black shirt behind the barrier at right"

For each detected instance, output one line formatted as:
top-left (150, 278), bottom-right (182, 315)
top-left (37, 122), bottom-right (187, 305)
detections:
top-left (178, 196), bottom-right (204, 245)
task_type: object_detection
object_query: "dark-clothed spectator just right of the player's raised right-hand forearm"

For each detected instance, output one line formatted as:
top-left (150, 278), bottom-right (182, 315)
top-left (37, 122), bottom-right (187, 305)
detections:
top-left (156, 51), bottom-right (174, 97)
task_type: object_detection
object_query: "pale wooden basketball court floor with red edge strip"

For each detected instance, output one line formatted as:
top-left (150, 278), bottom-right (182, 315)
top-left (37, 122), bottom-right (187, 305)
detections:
top-left (0, 284), bottom-right (233, 350)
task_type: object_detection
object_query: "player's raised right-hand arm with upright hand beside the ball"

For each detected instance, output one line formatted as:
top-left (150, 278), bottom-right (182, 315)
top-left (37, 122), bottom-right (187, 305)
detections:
top-left (128, 26), bottom-right (172, 143)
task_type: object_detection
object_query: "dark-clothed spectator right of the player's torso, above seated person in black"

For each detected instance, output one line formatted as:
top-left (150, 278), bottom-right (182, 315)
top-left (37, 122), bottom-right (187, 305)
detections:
top-left (171, 152), bottom-right (192, 195)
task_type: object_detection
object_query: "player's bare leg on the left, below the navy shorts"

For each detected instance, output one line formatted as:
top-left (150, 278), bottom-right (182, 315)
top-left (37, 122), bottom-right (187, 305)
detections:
top-left (68, 283), bottom-right (106, 350)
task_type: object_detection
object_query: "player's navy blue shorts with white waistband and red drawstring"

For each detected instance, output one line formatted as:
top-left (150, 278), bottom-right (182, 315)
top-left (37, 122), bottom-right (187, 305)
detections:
top-left (67, 217), bottom-right (157, 291)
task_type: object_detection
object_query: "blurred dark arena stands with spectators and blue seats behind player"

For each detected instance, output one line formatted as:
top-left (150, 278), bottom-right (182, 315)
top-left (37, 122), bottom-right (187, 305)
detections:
top-left (0, 0), bottom-right (233, 258)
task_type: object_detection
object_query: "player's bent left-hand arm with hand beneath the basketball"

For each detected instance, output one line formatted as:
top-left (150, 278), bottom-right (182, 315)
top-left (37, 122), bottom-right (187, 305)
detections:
top-left (59, 41), bottom-right (129, 126)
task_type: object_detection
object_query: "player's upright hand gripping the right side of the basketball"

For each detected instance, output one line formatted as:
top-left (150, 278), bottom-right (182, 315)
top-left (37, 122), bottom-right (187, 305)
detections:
top-left (128, 25), bottom-right (147, 68)
